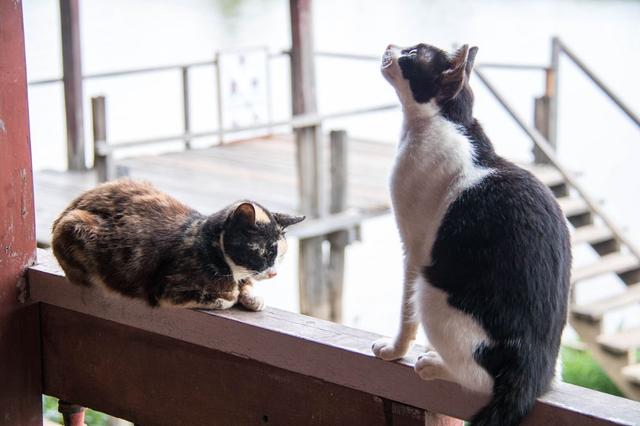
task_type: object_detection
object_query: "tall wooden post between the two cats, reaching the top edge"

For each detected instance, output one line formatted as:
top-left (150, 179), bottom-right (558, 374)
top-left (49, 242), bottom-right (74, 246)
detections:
top-left (289, 0), bottom-right (331, 318)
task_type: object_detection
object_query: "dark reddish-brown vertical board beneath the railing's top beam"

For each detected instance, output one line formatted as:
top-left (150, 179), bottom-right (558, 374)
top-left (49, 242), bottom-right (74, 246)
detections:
top-left (43, 304), bottom-right (424, 426)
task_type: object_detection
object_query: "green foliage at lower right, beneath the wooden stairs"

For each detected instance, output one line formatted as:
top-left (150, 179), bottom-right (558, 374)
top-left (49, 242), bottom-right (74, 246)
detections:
top-left (561, 347), bottom-right (624, 396)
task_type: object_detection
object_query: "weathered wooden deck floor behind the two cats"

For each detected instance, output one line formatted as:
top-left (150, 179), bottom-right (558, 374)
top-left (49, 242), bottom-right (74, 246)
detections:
top-left (34, 135), bottom-right (395, 246)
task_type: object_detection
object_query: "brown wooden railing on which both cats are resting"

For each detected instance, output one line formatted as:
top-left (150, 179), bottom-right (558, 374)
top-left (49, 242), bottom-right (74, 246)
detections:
top-left (28, 251), bottom-right (640, 425)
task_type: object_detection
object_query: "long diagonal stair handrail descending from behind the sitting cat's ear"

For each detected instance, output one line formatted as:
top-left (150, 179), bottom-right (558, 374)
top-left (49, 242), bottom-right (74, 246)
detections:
top-left (474, 69), bottom-right (640, 260)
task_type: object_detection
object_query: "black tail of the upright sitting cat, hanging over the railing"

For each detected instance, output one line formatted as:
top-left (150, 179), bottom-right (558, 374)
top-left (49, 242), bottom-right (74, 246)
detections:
top-left (470, 342), bottom-right (553, 426)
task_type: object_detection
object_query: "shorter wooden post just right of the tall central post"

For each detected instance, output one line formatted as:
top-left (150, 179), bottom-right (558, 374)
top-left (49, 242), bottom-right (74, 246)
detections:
top-left (327, 130), bottom-right (349, 322)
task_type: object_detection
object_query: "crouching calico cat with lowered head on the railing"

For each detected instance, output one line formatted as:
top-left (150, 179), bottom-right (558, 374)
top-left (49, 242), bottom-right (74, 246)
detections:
top-left (52, 180), bottom-right (304, 311)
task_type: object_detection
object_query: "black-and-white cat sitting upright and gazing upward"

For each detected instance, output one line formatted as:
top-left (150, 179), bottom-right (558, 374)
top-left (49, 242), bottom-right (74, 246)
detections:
top-left (372, 44), bottom-right (571, 426)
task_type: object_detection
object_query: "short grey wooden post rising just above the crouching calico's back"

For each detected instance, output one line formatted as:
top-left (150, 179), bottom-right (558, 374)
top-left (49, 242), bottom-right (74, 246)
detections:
top-left (91, 96), bottom-right (116, 183)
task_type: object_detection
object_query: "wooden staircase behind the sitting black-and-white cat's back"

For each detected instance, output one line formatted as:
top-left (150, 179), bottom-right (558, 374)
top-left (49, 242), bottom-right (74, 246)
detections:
top-left (527, 165), bottom-right (640, 401)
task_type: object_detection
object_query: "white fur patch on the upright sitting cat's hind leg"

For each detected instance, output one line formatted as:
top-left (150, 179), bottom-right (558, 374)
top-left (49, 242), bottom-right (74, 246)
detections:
top-left (416, 277), bottom-right (493, 393)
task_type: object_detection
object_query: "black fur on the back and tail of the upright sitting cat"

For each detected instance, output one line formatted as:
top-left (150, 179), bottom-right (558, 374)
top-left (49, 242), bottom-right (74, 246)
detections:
top-left (424, 157), bottom-right (571, 424)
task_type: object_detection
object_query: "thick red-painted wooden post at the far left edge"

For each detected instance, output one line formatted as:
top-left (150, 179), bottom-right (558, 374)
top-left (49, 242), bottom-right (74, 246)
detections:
top-left (0, 1), bottom-right (42, 426)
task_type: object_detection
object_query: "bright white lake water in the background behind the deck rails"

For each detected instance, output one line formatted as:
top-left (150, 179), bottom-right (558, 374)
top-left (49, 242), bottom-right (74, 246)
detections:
top-left (24, 0), bottom-right (640, 334)
